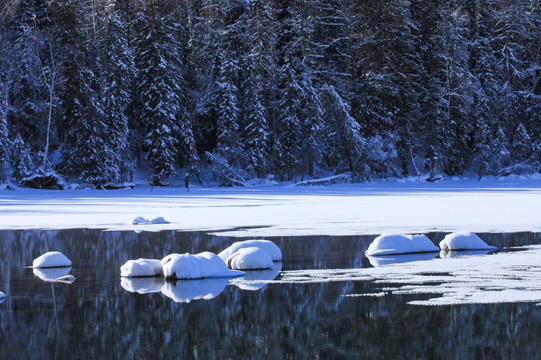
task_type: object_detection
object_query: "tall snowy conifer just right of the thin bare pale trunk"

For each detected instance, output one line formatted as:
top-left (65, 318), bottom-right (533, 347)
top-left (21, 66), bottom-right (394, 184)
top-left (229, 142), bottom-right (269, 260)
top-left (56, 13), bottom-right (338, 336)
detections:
top-left (54, 0), bottom-right (115, 185)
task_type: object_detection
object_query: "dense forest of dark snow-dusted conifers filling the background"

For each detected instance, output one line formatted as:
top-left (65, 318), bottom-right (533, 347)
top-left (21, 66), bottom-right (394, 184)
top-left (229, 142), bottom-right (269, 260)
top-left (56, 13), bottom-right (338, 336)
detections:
top-left (0, 0), bottom-right (541, 184)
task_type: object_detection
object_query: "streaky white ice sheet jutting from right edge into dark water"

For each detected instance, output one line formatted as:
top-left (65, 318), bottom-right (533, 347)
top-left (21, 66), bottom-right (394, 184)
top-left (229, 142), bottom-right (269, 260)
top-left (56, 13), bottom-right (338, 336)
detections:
top-left (269, 245), bottom-right (541, 306)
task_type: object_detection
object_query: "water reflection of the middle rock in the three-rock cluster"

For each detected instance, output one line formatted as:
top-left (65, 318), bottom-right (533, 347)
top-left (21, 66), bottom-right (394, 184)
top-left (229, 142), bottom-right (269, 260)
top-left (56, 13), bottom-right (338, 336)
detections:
top-left (161, 278), bottom-right (229, 303)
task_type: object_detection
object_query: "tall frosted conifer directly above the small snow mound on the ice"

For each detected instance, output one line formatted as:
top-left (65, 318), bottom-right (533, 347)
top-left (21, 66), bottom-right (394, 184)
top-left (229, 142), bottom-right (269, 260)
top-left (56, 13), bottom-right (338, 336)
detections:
top-left (135, 0), bottom-right (183, 183)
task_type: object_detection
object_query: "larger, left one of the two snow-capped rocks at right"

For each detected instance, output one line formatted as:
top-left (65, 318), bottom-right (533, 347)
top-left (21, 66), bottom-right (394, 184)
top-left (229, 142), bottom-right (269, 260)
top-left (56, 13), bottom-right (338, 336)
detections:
top-left (365, 234), bottom-right (439, 256)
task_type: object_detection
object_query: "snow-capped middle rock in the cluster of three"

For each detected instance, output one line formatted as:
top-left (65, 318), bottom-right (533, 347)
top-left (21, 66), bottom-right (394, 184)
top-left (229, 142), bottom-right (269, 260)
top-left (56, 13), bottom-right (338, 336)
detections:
top-left (161, 251), bottom-right (244, 279)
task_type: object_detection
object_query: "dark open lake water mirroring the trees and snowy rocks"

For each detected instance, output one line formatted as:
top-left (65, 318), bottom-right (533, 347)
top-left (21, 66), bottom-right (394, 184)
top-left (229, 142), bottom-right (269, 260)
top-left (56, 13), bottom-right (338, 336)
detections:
top-left (0, 230), bottom-right (541, 359)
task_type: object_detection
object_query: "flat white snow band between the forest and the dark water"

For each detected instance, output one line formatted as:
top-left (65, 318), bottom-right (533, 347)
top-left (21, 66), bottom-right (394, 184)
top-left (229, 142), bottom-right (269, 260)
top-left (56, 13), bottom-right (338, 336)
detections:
top-left (0, 176), bottom-right (541, 236)
